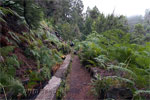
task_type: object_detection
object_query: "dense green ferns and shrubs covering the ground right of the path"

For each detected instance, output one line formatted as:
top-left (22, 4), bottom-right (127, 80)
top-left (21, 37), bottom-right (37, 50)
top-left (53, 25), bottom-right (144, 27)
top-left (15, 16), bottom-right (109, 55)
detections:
top-left (75, 8), bottom-right (150, 100)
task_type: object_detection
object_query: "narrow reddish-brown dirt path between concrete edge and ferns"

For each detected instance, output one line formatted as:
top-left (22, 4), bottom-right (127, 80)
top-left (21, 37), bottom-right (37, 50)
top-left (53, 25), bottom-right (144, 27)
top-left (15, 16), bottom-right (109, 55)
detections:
top-left (65, 56), bottom-right (94, 100)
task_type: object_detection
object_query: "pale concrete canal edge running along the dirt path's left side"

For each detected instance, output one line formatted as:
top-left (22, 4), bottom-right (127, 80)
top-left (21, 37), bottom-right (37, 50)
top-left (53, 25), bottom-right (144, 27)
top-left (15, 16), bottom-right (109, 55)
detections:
top-left (35, 54), bottom-right (71, 100)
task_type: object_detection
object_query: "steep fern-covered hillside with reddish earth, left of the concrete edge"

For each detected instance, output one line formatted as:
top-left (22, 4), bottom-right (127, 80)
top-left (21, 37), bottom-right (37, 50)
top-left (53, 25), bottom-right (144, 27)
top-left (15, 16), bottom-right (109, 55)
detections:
top-left (0, 2), bottom-right (70, 99)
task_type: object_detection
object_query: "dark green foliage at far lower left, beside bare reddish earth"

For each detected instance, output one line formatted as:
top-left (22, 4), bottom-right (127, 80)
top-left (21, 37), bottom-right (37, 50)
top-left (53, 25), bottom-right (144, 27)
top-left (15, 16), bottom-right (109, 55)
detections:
top-left (0, 46), bottom-right (23, 95)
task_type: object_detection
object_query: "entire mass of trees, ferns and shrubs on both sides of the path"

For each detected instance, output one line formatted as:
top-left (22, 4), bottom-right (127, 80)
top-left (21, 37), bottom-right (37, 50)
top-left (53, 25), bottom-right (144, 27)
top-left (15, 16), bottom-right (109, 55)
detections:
top-left (0, 0), bottom-right (150, 100)
